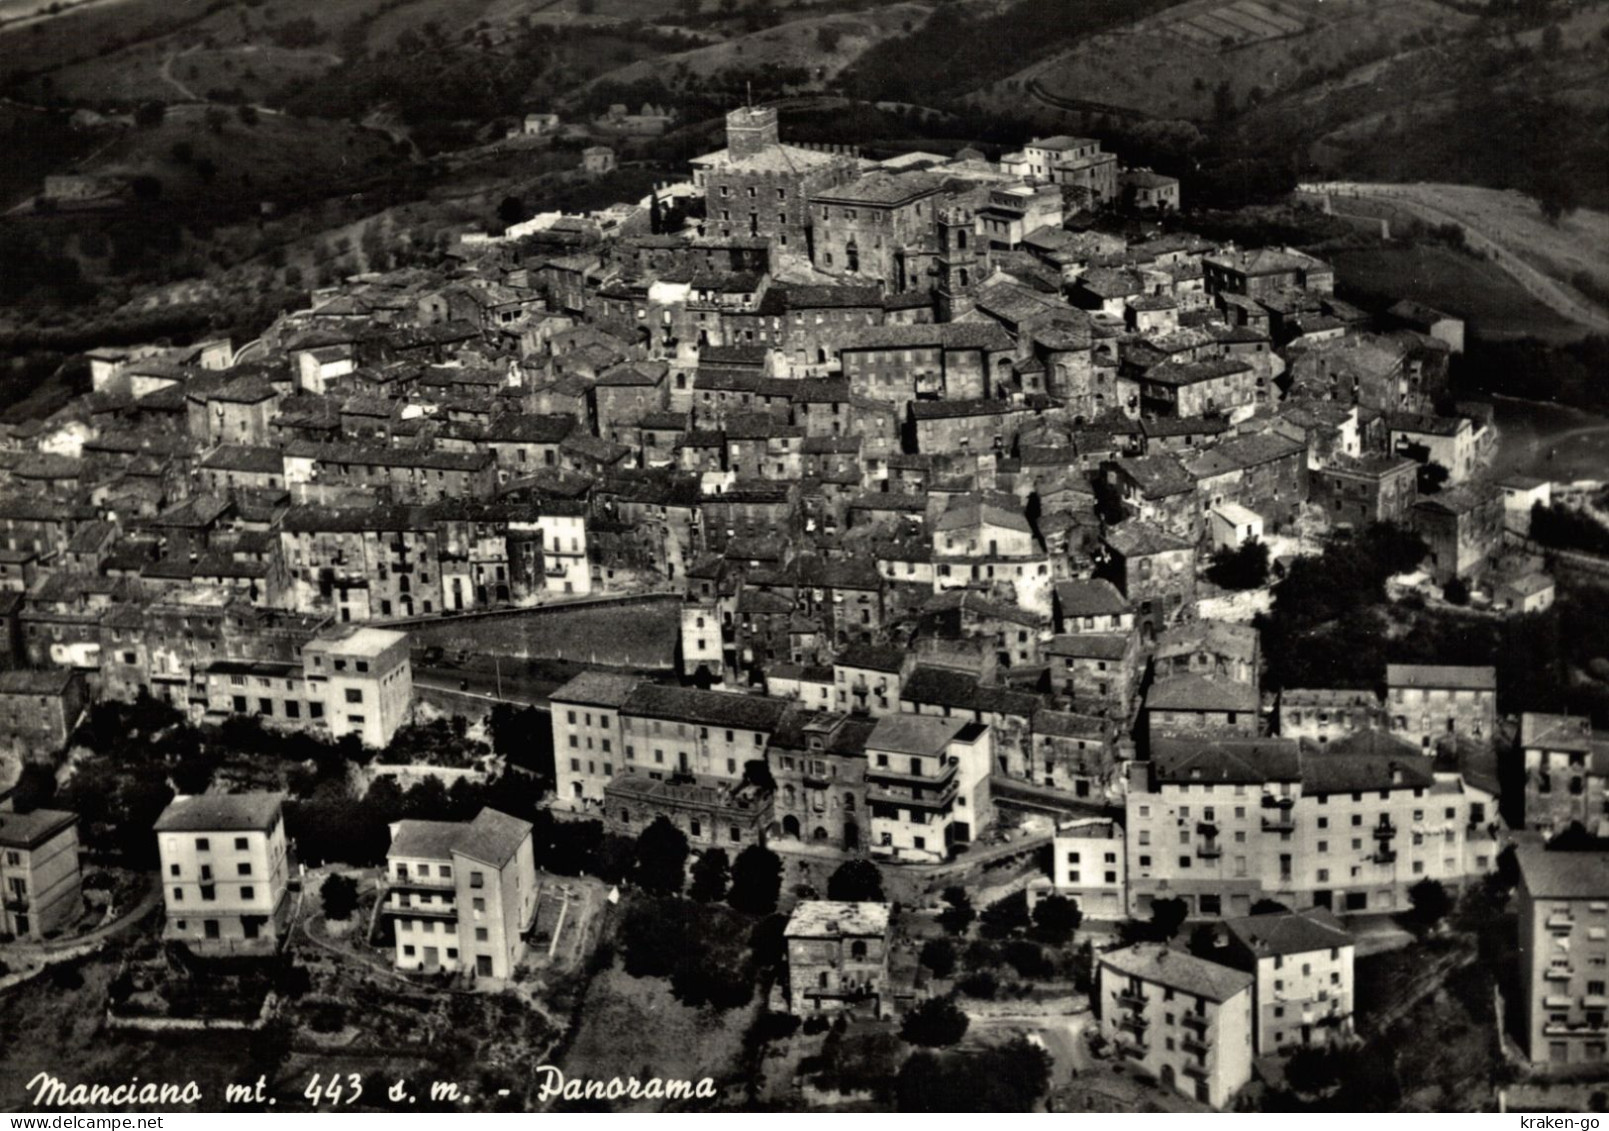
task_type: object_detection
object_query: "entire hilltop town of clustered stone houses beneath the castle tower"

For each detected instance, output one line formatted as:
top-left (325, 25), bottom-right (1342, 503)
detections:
top-left (0, 105), bottom-right (1609, 1110)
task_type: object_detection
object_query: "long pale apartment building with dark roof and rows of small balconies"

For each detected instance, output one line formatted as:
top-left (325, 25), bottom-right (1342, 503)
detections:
top-left (1123, 732), bottom-right (1503, 917)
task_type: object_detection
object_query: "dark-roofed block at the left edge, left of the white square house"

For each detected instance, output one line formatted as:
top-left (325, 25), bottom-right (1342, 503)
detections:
top-left (0, 809), bottom-right (84, 941)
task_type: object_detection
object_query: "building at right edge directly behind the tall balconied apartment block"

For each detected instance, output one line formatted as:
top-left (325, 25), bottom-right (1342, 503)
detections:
top-left (1519, 711), bottom-right (1609, 835)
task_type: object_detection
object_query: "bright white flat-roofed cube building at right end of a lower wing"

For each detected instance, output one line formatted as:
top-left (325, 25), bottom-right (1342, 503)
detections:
top-left (302, 624), bottom-right (414, 748)
